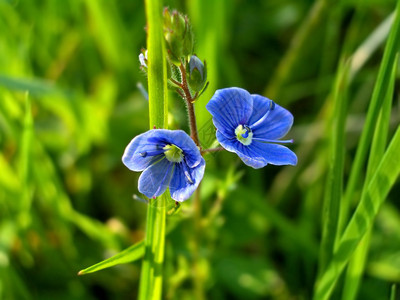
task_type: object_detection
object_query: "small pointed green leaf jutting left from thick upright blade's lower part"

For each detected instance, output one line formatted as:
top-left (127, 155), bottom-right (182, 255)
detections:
top-left (78, 241), bottom-right (145, 275)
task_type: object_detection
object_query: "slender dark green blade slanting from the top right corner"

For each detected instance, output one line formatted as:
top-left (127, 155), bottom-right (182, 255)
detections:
top-left (338, 2), bottom-right (400, 234)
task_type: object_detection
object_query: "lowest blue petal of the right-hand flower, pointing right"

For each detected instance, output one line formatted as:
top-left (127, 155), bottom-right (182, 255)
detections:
top-left (217, 131), bottom-right (297, 169)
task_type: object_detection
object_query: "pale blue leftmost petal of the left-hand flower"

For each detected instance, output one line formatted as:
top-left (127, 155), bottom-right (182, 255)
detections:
top-left (122, 130), bottom-right (163, 172)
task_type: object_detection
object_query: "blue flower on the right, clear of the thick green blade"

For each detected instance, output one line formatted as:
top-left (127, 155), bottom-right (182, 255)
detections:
top-left (206, 88), bottom-right (297, 169)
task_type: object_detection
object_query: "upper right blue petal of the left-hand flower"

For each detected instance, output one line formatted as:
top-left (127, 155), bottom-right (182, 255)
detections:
top-left (159, 129), bottom-right (201, 168)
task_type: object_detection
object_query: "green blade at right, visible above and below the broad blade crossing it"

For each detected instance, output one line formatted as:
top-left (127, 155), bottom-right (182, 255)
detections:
top-left (342, 55), bottom-right (399, 300)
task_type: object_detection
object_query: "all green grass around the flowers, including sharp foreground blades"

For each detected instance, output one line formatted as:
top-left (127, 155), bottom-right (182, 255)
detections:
top-left (0, 0), bottom-right (400, 300)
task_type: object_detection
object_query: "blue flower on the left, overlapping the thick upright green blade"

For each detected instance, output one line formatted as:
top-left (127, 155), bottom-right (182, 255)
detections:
top-left (122, 129), bottom-right (205, 202)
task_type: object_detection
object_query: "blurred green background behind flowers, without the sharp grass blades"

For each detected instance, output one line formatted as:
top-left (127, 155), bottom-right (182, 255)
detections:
top-left (0, 0), bottom-right (400, 300)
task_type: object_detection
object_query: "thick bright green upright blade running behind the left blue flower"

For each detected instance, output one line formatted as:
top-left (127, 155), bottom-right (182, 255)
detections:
top-left (138, 0), bottom-right (168, 300)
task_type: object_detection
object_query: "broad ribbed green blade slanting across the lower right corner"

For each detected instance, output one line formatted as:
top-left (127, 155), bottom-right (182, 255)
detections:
top-left (314, 126), bottom-right (400, 300)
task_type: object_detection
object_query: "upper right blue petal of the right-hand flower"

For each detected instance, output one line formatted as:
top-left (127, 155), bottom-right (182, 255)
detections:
top-left (248, 95), bottom-right (293, 140)
